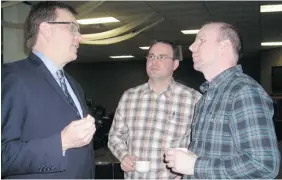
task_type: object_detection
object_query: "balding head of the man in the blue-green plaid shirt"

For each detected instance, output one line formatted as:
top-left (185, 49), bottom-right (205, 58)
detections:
top-left (189, 22), bottom-right (241, 79)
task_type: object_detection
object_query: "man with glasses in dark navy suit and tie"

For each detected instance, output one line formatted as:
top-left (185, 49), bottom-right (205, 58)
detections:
top-left (1, 1), bottom-right (96, 179)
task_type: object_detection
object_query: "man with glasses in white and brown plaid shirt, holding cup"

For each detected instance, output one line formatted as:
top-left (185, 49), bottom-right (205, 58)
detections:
top-left (108, 41), bottom-right (201, 179)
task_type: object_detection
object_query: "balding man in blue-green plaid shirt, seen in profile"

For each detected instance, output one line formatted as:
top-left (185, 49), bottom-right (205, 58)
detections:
top-left (165, 22), bottom-right (280, 179)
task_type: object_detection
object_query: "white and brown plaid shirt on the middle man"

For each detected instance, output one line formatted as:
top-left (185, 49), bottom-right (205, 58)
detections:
top-left (108, 80), bottom-right (201, 179)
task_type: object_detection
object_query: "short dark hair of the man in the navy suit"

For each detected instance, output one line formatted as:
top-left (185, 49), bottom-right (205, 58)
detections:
top-left (24, 1), bottom-right (77, 50)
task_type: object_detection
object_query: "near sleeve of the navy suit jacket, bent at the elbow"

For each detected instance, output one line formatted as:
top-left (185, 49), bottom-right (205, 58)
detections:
top-left (1, 68), bottom-right (65, 177)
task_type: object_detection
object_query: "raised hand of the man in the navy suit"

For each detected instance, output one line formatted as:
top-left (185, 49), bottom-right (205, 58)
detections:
top-left (61, 115), bottom-right (96, 152)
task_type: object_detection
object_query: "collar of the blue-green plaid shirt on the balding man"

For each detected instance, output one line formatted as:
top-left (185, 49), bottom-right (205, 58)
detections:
top-left (200, 65), bottom-right (243, 93)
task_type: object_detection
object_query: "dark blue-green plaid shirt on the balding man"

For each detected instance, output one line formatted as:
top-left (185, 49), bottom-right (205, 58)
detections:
top-left (186, 65), bottom-right (280, 179)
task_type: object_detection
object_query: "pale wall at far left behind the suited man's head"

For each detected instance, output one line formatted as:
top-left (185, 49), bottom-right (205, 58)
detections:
top-left (2, 3), bottom-right (30, 63)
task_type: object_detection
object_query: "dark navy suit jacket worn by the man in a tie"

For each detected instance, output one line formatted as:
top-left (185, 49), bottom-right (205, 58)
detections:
top-left (1, 54), bottom-right (94, 179)
